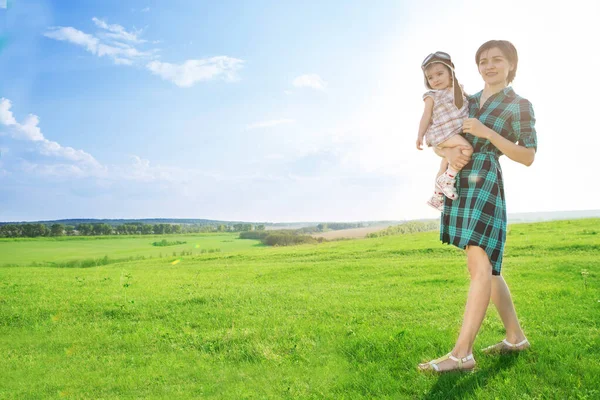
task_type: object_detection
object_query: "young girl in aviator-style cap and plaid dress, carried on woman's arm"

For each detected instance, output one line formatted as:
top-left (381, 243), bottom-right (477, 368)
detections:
top-left (417, 51), bottom-right (473, 211)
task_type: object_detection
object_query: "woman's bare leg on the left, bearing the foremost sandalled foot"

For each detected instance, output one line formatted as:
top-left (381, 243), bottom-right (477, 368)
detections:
top-left (420, 246), bottom-right (492, 371)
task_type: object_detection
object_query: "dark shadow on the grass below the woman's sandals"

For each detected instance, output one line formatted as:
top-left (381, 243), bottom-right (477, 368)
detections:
top-left (423, 353), bottom-right (519, 400)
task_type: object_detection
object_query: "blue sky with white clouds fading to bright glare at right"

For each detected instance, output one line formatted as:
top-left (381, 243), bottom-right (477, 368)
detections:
top-left (0, 0), bottom-right (600, 222)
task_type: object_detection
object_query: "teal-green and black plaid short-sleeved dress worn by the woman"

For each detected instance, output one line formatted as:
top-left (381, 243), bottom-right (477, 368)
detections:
top-left (440, 87), bottom-right (537, 275)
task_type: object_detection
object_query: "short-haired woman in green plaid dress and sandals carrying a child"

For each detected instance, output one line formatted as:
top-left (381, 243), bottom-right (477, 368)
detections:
top-left (419, 40), bottom-right (537, 372)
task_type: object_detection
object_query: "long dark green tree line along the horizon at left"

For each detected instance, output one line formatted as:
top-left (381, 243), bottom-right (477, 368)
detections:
top-left (0, 223), bottom-right (265, 238)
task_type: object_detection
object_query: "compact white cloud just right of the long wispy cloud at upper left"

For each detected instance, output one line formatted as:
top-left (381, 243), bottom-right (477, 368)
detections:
top-left (146, 56), bottom-right (244, 87)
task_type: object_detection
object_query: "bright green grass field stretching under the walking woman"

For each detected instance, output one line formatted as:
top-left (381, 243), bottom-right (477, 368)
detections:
top-left (0, 219), bottom-right (600, 399)
